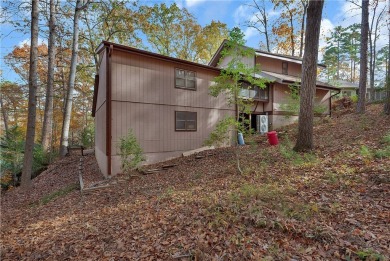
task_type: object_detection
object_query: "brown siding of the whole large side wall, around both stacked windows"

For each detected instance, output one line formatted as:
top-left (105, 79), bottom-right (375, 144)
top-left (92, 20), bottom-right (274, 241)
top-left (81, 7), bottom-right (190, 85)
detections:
top-left (111, 50), bottom-right (234, 160)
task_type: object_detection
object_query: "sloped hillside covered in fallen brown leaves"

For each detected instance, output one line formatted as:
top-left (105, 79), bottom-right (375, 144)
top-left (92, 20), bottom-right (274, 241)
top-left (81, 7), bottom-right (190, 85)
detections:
top-left (1, 105), bottom-right (390, 260)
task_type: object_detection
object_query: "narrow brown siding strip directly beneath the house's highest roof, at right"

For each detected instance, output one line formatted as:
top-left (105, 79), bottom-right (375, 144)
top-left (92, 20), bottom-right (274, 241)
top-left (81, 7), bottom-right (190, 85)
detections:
top-left (256, 56), bottom-right (302, 77)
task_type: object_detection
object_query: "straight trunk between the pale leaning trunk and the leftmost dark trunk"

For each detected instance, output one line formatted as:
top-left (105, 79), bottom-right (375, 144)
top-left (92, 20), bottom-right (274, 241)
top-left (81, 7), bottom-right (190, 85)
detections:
top-left (42, 0), bottom-right (56, 152)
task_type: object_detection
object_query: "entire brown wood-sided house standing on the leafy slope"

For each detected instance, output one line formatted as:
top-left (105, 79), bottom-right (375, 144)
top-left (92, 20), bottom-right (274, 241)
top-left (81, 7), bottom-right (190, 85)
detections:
top-left (92, 41), bottom-right (338, 176)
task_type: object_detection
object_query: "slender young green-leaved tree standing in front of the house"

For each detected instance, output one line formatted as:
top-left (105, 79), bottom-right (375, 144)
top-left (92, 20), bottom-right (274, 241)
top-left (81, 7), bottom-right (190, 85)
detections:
top-left (210, 27), bottom-right (267, 174)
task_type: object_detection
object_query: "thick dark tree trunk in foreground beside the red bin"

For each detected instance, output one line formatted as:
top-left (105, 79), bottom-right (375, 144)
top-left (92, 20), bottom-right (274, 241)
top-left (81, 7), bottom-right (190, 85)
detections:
top-left (294, 0), bottom-right (324, 151)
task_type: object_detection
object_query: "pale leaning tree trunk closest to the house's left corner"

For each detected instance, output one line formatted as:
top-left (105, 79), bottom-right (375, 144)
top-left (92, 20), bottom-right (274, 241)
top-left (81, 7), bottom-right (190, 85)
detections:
top-left (60, 0), bottom-right (89, 157)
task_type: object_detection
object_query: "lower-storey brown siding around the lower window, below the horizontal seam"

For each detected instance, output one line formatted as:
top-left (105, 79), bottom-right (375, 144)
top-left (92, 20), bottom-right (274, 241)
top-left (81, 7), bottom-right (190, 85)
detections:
top-left (112, 101), bottom-right (234, 155)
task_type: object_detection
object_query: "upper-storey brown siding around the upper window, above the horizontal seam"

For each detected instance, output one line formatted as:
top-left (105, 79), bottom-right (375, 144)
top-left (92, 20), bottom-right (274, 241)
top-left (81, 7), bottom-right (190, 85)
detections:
top-left (112, 51), bottom-right (229, 109)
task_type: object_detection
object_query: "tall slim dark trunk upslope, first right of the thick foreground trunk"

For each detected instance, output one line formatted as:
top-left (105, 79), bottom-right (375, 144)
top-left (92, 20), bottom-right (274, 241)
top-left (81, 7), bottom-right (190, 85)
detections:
top-left (356, 0), bottom-right (369, 113)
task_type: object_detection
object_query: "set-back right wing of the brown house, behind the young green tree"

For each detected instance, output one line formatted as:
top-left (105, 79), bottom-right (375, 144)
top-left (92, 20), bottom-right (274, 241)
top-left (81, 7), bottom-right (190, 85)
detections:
top-left (209, 40), bottom-right (340, 129)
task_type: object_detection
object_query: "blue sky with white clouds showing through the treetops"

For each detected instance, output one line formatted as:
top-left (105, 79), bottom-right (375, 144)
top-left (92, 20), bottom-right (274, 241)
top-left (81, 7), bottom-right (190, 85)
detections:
top-left (0, 0), bottom-right (390, 81)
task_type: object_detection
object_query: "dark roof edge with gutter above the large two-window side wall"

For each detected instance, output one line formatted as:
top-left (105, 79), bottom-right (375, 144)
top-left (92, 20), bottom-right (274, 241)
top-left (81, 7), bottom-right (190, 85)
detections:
top-left (96, 41), bottom-right (220, 72)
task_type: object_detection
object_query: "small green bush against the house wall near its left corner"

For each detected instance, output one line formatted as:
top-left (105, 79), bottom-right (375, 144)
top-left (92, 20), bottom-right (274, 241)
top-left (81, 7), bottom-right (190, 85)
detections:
top-left (119, 129), bottom-right (145, 173)
